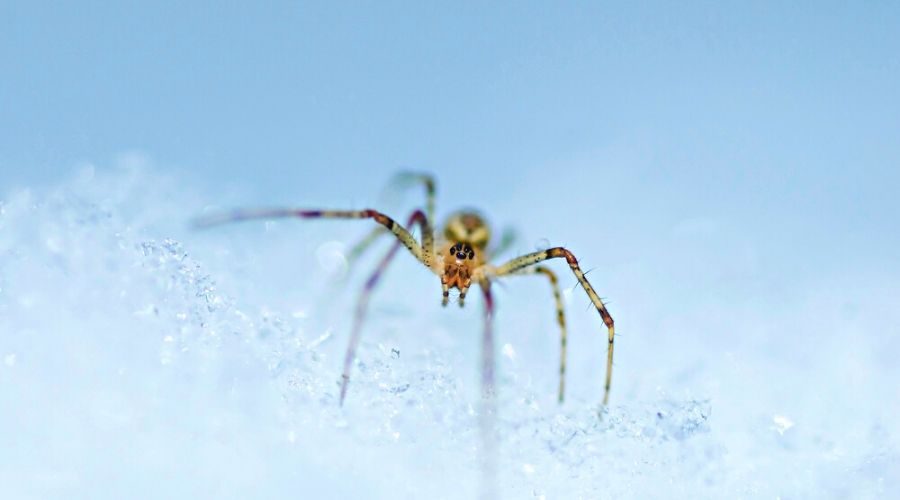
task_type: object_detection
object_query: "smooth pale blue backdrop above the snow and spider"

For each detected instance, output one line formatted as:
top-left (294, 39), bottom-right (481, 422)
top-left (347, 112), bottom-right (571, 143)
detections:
top-left (0, 2), bottom-right (900, 304)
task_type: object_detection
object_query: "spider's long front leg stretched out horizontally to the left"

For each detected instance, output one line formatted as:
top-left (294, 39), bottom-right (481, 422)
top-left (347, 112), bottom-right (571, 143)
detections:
top-left (193, 208), bottom-right (437, 273)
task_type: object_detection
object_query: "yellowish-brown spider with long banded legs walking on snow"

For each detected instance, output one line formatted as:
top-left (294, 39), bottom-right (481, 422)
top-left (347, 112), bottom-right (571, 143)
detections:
top-left (195, 172), bottom-right (615, 405)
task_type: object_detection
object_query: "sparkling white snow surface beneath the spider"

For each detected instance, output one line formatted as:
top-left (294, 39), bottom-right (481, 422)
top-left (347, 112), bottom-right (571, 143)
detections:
top-left (0, 169), bottom-right (900, 498)
